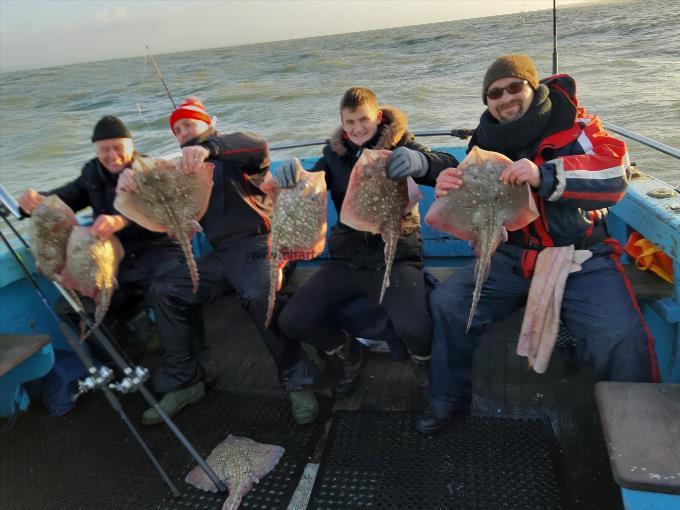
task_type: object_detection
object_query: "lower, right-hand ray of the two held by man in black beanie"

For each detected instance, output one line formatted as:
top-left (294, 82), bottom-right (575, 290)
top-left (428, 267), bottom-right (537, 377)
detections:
top-left (61, 227), bottom-right (125, 329)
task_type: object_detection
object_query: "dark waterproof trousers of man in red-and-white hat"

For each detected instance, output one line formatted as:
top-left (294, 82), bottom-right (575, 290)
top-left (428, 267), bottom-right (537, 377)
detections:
top-left (150, 235), bottom-right (312, 392)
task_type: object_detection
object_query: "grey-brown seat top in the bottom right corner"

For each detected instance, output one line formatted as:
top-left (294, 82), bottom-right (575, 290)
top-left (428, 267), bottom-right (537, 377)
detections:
top-left (595, 382), bottom-right (680, 498)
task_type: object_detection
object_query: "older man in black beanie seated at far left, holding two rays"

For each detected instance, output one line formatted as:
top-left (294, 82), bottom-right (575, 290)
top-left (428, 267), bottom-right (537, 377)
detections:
top-left (19, 115), bottom-right (189, 364)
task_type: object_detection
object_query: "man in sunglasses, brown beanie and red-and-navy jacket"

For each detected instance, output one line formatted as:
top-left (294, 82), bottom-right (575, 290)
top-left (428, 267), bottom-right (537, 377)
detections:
top-left (415, 55), bottom-right (658, 434)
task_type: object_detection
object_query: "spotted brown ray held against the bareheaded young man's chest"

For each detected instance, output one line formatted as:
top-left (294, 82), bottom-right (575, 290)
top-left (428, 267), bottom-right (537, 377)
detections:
top-left (340, 149), bottom-right (417, 303)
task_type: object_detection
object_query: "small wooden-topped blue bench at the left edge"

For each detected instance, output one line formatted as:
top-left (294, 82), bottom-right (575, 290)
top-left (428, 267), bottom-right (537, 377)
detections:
top-left (0, 334), bottom-right (54, 416)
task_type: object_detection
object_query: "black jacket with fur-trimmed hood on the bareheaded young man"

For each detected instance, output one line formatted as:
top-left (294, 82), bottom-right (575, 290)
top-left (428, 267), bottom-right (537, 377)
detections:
top-left (314, 106), bottom-right (458, 269)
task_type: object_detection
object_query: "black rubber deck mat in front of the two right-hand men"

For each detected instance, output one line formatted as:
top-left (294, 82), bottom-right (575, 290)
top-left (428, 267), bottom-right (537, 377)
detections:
top-left (308, 411), bottom-right (561, 510)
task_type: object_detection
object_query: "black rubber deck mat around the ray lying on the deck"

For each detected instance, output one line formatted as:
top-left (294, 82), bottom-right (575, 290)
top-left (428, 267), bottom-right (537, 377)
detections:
top-left (0, 390), bottom-right (330, 510)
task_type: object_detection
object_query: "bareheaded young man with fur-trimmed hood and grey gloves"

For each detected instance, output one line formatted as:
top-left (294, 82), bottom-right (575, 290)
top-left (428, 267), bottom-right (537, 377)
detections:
top-left (278, 87), bottom-right (458, 398)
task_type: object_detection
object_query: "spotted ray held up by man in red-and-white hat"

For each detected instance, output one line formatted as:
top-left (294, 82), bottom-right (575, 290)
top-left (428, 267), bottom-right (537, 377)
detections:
top-left (113, 157), bottom-right (213, 292)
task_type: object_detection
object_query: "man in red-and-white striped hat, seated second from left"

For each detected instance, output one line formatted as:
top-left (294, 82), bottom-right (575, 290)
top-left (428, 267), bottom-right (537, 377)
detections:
top-left (120, 97), bottom-right (319, 425)
